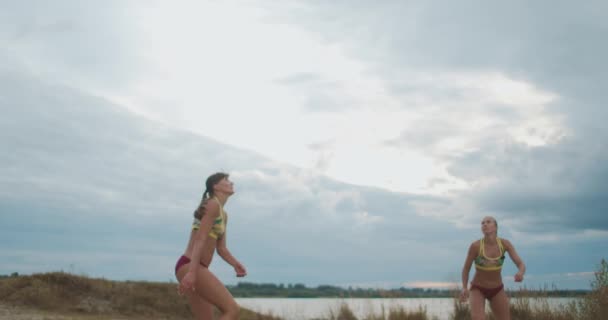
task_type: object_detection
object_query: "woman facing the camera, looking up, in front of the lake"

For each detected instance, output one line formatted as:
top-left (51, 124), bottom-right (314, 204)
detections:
top-left (460, 217), bottom-right (526, 320)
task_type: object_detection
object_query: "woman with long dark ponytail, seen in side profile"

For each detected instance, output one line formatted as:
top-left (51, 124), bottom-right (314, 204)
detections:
top-left (175, 172), bottom-right (247, 320)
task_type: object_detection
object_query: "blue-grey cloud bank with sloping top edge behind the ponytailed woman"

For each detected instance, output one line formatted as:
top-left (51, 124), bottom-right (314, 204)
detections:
top-left (0, 64), bottom-right (470, 283)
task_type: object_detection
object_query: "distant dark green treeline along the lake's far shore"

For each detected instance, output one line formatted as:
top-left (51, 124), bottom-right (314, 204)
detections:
top-left (227, 282), bottom-right (589, 298)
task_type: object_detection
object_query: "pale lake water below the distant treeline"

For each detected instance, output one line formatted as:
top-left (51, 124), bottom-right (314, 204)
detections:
top-left (236, 298), bottom-right (575, 320)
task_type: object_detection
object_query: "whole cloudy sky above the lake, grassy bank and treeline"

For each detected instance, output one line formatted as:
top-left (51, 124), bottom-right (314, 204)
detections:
top-left (0, 0), bottom-right (608, 289)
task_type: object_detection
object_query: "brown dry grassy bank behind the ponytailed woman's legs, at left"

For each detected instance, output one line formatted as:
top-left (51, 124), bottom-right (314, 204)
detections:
top-left (0, 272), bottom-right (278, 320)
